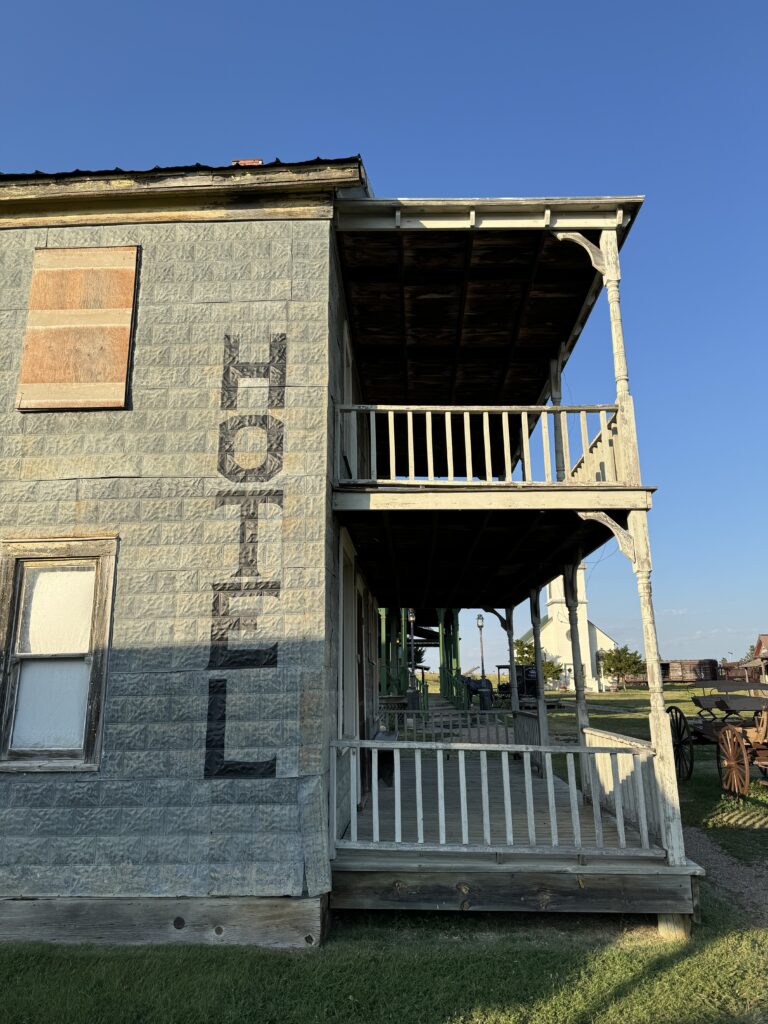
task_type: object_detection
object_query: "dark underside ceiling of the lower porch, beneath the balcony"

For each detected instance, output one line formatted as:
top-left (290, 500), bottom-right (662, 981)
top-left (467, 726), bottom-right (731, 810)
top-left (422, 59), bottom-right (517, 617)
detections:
top-left (341, 509), bottom-right (627, 621)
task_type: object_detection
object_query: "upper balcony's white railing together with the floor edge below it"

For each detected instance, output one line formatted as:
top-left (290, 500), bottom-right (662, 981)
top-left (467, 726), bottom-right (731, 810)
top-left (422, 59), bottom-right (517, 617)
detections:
top-left (334, 404), bottom-right (650, 510)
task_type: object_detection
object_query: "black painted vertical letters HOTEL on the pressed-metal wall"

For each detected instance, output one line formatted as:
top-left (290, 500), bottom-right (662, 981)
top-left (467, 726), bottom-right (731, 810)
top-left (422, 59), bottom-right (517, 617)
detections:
top-left (205, 334), bottom-right (287, 778)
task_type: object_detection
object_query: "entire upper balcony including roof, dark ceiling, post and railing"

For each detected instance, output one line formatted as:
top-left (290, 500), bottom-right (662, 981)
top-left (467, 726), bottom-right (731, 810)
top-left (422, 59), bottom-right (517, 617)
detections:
top-left (334, 197), bottom-right (650, 511)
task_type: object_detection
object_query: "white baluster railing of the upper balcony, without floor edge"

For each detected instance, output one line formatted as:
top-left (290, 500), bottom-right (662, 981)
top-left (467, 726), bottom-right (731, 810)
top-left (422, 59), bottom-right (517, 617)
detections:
top-left (335, 406), bottom-right (634, 487)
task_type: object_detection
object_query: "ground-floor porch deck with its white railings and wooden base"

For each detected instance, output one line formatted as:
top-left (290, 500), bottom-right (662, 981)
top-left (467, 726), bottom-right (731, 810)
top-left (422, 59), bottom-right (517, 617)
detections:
top-left (329, 708), bottom-right (701, 930)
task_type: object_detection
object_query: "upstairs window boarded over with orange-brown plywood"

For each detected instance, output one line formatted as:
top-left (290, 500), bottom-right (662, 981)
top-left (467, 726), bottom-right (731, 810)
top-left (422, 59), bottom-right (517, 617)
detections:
top-left (16, 246), bottom-right (138, 410)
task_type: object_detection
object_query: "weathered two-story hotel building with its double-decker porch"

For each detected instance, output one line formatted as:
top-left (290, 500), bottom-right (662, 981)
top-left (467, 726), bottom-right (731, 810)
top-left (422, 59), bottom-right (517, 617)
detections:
top-left (0, 158), bottom-right (698, 945)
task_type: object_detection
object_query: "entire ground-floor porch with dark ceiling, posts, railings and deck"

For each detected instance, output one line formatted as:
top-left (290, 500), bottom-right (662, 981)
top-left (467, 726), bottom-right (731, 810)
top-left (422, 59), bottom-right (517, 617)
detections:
top-left (329, 510), bottom-right (701, 935)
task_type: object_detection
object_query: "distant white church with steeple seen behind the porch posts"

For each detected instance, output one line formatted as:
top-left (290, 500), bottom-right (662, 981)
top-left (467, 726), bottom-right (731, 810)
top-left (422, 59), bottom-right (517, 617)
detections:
top-left (521, 565), bottom-right (618, 690)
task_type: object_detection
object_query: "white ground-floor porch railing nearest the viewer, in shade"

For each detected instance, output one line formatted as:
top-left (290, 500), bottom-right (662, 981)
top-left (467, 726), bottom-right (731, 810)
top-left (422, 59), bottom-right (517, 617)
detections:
top-left (330, 739), bottom-right (664, 857)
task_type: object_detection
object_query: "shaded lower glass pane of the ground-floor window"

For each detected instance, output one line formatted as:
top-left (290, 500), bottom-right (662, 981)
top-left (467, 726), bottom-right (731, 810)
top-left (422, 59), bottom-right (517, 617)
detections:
top-left (10, 657), bottom-right (90, 751)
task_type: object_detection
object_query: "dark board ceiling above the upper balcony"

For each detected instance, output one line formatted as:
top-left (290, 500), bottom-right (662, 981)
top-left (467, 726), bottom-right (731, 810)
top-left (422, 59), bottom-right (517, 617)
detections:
top-left (337, 200), bottom-right (639, 406)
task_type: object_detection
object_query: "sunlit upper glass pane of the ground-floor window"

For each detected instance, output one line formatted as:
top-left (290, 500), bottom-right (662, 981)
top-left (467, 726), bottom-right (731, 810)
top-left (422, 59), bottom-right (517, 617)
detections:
top-left (16, 561), bottom-right (96, 654)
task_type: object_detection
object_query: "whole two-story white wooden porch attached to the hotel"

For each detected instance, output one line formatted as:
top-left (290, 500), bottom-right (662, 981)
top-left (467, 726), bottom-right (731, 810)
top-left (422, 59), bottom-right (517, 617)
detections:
top-left (329, 197), bottom-right (699, 928)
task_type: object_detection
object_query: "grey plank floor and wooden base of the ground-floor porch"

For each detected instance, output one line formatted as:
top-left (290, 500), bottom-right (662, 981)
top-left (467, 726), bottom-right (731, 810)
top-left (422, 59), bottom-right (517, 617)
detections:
top-left (330, 733), bottom-right (702, 915)
